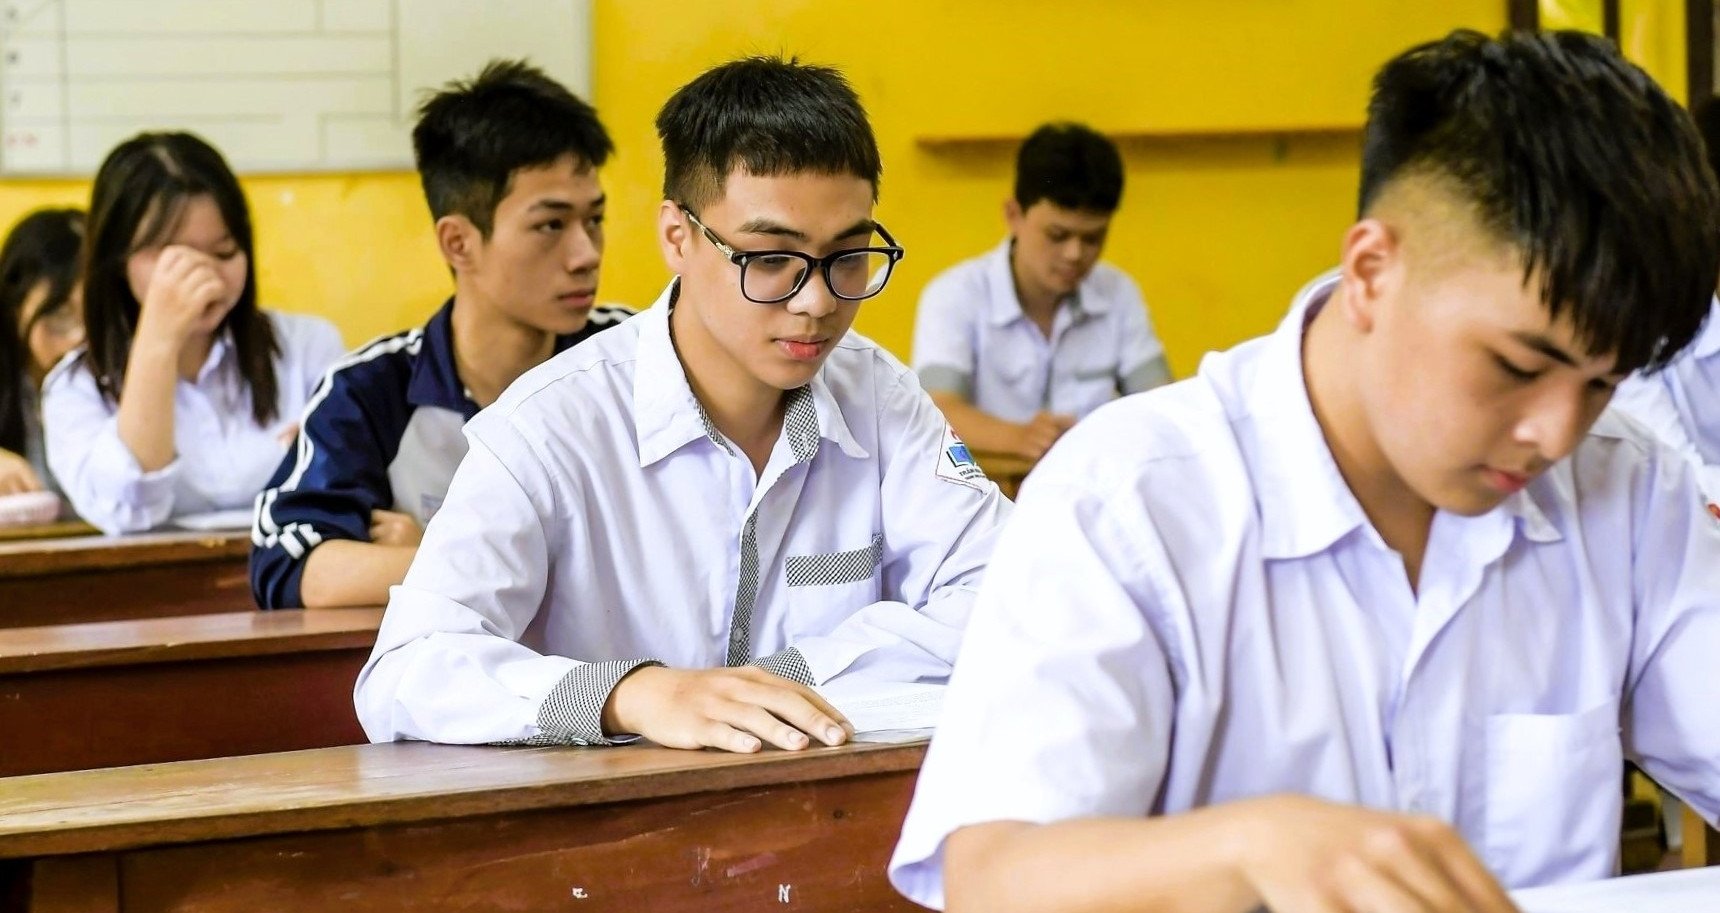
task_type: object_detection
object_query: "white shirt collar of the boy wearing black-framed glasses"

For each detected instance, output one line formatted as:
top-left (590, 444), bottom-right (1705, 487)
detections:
top-left (630, 279), bottom-right (870, 468)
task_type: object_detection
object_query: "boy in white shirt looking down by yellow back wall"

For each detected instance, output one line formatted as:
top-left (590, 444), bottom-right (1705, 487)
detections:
top-left (913, 124), bottom-right (1171, 459)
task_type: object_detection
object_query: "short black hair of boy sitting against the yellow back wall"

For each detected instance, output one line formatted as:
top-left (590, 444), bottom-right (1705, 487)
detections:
top-left (1015, 124), bottom-right (1123, 215)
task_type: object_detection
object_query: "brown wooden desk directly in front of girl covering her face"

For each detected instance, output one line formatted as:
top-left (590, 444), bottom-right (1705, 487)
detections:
top-left (0, 531), bottom-right (255, 628)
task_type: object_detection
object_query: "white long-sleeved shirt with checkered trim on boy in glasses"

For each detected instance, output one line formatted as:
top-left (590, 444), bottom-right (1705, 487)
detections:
top-left (356, 284), bottom-right (1010, 744)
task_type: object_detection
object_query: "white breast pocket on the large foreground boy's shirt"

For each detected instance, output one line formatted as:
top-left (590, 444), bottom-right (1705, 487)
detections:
top-left (1484, 698), bottom-right (1624, 885)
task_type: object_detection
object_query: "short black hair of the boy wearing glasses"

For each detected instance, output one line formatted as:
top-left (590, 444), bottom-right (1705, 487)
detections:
top-left (657, 57), bottom-right (884, 210)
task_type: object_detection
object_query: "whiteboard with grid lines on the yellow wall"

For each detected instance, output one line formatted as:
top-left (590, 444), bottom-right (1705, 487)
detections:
top-left (0, 0), bottom-right (592, 177)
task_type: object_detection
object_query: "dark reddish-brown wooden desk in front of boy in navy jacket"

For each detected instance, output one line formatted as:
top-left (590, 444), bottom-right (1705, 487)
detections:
top-left (0, 609), bottom-right (382, 780)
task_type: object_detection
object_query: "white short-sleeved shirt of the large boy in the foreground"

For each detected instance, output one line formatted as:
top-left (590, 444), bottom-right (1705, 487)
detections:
top-left (891, 273), bottom-right (1720, 906)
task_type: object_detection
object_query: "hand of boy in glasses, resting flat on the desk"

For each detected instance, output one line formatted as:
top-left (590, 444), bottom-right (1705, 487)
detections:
top-left (604, 665), bottom-right (850, 753)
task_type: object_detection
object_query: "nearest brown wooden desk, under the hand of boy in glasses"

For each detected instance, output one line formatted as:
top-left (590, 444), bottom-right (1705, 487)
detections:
top-left (0, 744), bottom-right (924, 913)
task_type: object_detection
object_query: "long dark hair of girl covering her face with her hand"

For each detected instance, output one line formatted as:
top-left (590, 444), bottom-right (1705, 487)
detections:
top-left (84, 132), bottom-right (280, 425)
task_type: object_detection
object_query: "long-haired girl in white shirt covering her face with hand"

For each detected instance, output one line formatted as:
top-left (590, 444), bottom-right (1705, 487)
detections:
top-left (43, 132), bottom-right (344, 533)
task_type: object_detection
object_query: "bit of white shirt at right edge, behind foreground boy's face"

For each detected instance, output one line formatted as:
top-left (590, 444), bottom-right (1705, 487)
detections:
top-left (1613, 297), bottom-right (1720, 500)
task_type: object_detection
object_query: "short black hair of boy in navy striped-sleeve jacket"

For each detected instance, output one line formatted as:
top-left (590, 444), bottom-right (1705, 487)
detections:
top-left (413, 60), bottom-right (616, 237)
